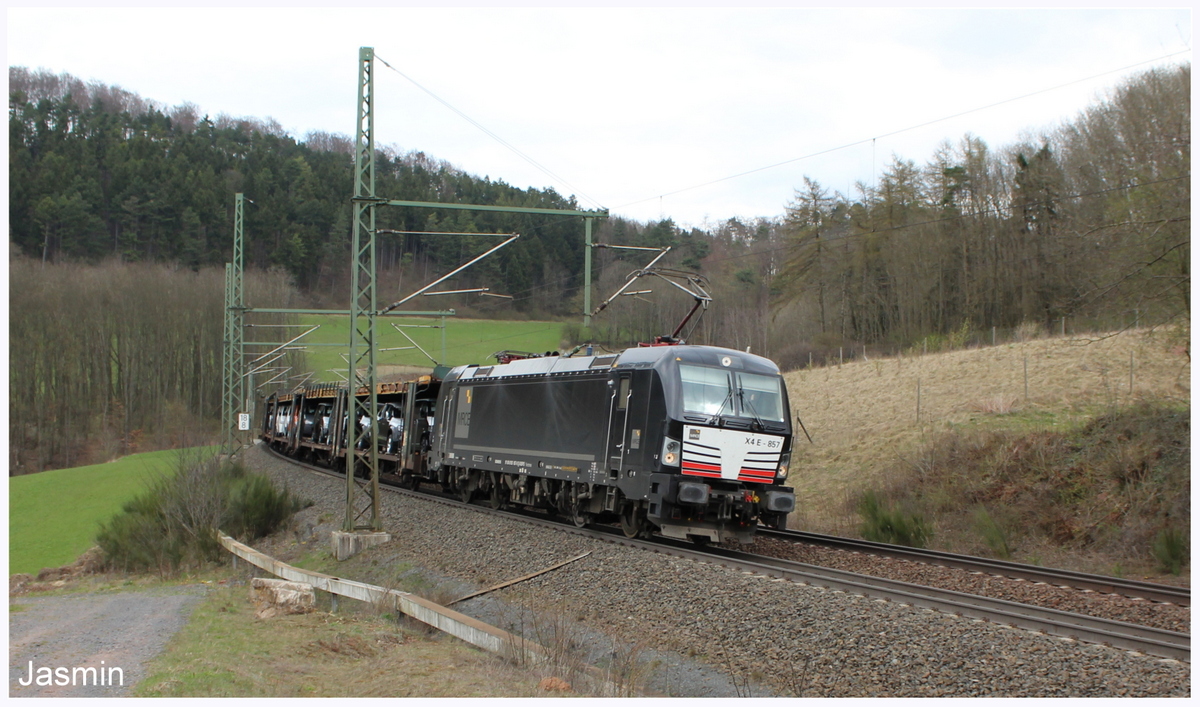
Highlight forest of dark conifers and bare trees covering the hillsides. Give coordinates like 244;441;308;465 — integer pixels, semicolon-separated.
8;65;1190;468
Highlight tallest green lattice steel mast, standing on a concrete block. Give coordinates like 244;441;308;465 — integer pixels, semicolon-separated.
342;47;383;533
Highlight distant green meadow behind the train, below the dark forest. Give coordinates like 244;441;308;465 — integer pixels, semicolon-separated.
292;314;563;382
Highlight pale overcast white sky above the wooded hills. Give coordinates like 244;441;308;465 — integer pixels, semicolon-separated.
6;7;1192;227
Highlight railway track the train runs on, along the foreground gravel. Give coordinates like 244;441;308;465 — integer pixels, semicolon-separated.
262;450;1190;663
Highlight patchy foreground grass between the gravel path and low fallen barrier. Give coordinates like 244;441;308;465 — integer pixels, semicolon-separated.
134;578;538;697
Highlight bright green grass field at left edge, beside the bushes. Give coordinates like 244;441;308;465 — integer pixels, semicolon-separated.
8;450;216;575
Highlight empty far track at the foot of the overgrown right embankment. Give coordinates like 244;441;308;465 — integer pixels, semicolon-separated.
758;528;1192;606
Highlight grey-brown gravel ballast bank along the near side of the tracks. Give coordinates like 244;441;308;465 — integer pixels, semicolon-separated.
247;450;1190;697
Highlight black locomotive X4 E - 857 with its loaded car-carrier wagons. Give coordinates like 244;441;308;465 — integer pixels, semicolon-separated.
263;346;796;543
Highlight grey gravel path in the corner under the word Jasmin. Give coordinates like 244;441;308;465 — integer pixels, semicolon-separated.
8;587;205;697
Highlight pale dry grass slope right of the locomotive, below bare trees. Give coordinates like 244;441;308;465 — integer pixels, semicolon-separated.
785;330;1192;534
